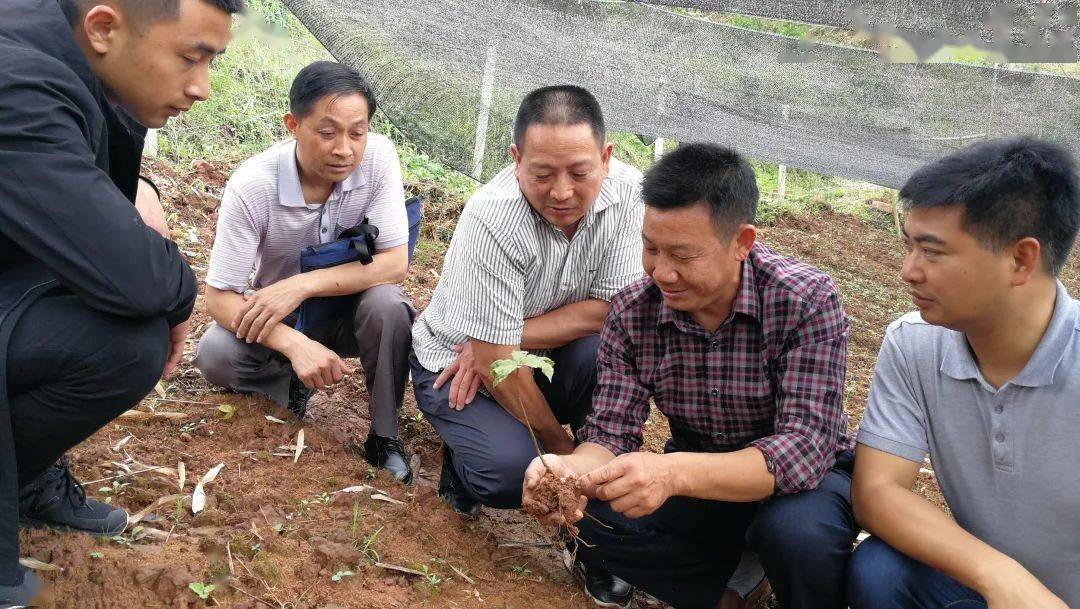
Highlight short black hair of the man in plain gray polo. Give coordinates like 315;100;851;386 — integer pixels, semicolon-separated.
900;137;1080;275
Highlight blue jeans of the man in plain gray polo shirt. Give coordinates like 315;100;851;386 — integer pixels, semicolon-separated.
848;537;986;609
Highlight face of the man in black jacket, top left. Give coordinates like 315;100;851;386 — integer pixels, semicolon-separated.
84;0;231;128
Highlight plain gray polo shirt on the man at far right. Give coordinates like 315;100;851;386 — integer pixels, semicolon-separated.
859;283;1080;607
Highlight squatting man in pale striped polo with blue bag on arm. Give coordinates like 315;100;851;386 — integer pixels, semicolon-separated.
195;62;414;482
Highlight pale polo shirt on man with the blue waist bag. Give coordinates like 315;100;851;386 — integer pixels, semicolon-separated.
206;132;408;293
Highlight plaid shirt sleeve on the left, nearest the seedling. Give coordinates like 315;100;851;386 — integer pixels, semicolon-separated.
578;312;651;455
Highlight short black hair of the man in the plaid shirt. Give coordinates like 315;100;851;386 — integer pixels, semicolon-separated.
642;143;759;238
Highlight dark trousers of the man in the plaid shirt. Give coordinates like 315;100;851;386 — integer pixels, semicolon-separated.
578;451;858;609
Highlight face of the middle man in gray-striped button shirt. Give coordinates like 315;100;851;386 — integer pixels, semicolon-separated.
510;123;612;232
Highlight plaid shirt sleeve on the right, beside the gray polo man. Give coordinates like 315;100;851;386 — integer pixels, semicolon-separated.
751;279;849;495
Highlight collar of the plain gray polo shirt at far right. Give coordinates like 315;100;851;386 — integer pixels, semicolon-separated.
941;281;1080;387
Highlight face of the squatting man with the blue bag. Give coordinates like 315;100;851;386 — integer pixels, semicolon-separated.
285;93;370;185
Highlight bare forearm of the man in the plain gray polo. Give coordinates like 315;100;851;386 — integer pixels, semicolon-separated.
851;444;1067;609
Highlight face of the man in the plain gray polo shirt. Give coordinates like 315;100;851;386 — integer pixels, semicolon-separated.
900;206;1015;331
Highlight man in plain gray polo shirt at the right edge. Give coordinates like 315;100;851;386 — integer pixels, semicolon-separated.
849;138;1080;609
